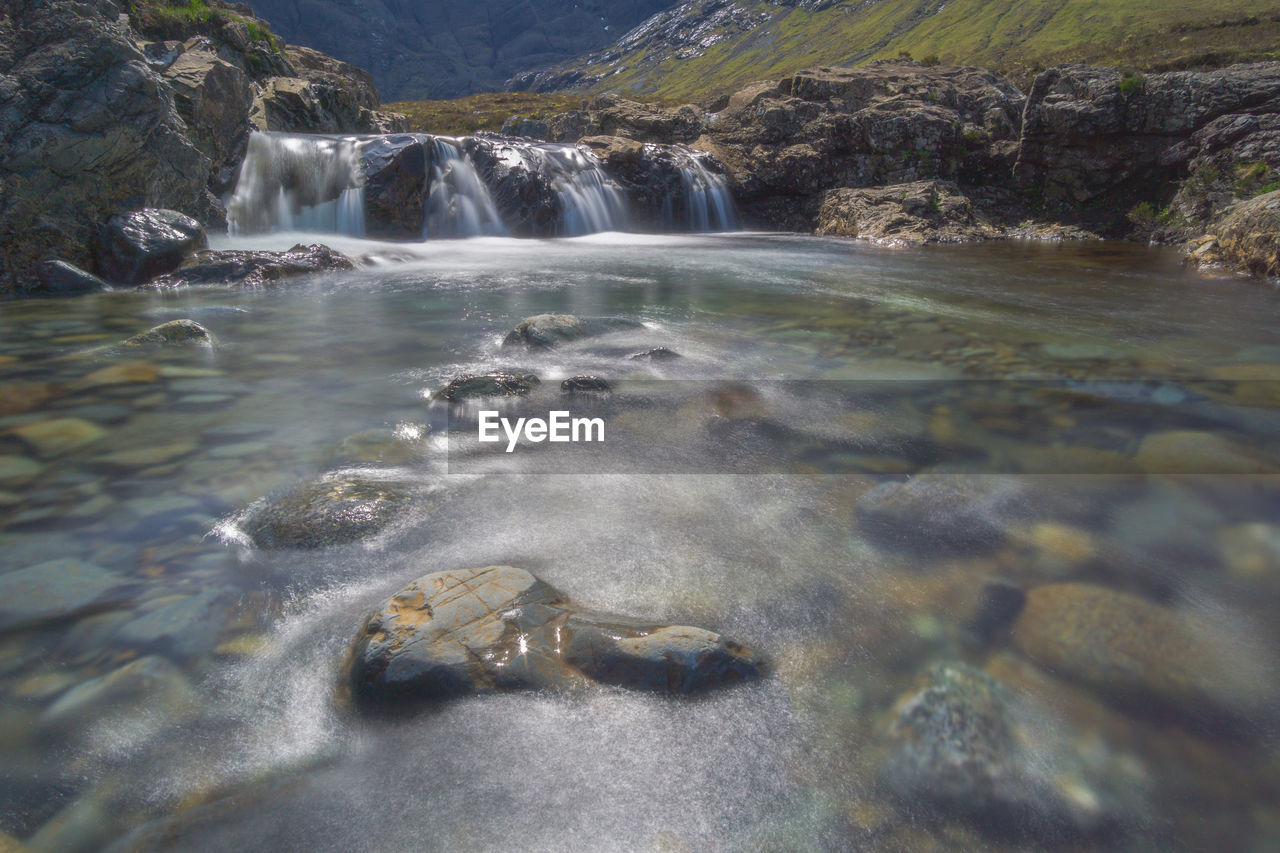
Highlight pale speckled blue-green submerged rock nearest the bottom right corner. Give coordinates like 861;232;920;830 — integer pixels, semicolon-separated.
878;662;1146;839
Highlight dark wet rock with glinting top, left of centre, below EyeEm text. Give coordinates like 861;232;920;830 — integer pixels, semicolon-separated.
239;478;412;548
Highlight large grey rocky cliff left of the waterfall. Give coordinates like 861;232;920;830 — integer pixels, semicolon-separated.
0;0;397;292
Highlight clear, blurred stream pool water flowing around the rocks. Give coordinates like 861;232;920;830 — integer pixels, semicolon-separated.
0;234;1280;850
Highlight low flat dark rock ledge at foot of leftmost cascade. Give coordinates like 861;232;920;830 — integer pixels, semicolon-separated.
148;243;356;288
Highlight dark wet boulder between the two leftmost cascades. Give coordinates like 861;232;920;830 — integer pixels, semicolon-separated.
360;133;433;240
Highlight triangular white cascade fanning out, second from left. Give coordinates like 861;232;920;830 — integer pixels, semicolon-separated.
422;136;507;240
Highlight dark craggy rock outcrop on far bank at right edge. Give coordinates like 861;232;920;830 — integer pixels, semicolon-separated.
1015;63;1280;234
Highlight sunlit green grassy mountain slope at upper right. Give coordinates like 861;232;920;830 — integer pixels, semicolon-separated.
509;0;1280;99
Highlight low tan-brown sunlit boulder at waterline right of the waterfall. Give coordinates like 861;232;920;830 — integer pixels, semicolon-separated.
814;181;1000;246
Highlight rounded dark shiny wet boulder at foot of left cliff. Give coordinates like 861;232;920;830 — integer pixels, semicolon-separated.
93;207;209;284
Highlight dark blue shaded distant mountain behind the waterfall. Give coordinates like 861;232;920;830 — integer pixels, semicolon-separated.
241;0;672;100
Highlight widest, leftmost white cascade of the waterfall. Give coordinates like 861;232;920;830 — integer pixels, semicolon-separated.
227;132;365;237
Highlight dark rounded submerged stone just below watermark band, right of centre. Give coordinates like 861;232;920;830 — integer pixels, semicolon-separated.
854;475;1019;556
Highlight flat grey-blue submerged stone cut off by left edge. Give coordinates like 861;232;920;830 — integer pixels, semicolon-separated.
0;558;125;631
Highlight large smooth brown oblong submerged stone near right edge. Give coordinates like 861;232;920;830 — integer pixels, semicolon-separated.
1012;584;1275;722
